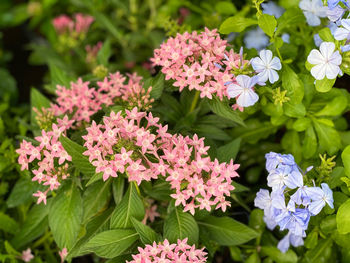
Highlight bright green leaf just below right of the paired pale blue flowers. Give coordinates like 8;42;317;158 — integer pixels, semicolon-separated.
282;64;304;104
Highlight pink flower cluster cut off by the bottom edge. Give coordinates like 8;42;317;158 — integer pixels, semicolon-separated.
127;238;207;263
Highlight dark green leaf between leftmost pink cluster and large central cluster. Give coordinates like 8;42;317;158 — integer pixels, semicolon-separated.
60;135;96;176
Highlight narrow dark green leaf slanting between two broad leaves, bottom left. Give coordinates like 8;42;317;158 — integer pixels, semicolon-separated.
67;208;113;261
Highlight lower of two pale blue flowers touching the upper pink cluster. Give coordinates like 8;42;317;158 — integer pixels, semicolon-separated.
227;75;259;107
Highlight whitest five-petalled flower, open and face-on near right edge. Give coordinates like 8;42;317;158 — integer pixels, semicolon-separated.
307;42;342;80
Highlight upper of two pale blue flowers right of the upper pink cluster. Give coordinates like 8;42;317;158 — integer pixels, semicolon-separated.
251;50;282;83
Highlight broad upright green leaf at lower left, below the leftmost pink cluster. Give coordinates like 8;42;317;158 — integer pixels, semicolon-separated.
49;184;83;250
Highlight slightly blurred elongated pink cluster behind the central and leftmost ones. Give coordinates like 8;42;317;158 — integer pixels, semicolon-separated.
50;72;154;128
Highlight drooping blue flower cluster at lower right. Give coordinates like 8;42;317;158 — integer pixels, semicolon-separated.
254;152;333;252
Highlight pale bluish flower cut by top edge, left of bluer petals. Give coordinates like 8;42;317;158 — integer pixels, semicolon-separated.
299;0;328;26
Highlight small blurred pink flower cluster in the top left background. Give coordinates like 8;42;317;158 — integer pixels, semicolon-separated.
52;13;94;35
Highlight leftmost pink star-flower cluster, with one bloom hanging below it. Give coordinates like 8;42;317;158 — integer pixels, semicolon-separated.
16;124;72;204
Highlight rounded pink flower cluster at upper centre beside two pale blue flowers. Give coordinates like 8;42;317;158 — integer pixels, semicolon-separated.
151;28;245;99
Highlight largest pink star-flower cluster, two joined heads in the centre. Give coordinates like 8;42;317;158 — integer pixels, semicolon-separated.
83;108;239;214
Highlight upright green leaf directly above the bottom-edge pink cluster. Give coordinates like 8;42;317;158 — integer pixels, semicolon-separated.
164;207;199;244
